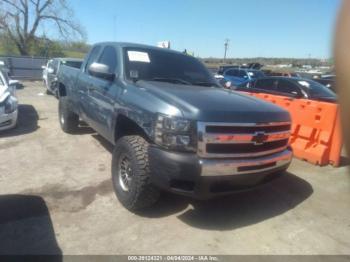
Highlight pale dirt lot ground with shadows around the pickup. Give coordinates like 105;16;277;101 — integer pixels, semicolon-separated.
0;82;350;254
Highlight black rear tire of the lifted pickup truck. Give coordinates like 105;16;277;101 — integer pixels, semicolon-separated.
58;96;79;134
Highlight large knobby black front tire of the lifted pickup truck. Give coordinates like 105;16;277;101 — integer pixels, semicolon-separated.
112;136;160;211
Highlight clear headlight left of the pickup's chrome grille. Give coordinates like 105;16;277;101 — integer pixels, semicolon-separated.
155;115;196;151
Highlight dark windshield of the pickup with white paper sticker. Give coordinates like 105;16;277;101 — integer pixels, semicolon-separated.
124;48;217;86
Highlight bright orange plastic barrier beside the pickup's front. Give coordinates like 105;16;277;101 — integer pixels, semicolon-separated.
242;92;343;167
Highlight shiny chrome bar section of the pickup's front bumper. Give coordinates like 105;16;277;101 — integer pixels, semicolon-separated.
199;149;293;177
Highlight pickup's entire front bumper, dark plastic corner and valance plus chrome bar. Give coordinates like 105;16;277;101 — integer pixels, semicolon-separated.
149;147;292;199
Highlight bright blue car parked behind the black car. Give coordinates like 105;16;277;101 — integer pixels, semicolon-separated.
224;69;265;85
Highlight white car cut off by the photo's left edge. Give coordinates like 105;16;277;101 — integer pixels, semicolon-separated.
0;70;18;131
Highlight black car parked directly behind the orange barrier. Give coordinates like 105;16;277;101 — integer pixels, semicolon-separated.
234;77;337;102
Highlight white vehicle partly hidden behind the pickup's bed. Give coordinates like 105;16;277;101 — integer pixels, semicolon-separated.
43;58;83;95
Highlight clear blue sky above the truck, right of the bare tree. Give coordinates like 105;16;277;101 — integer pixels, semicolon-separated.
69;0;340;58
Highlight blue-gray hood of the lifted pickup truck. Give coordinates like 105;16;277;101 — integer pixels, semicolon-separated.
137;81;290;123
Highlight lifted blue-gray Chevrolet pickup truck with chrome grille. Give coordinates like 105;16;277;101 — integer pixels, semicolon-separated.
58;43;292;210
